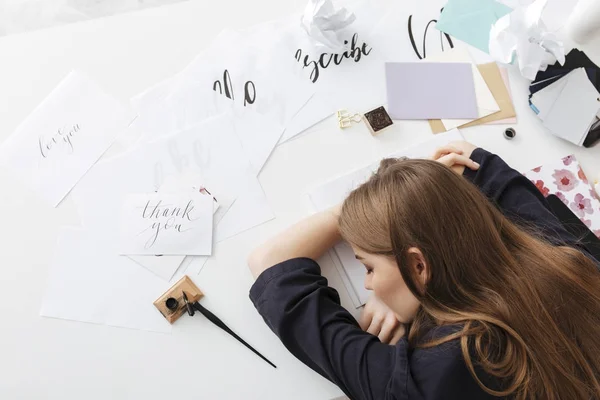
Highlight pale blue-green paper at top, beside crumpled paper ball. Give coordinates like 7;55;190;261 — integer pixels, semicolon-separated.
435;0;512;53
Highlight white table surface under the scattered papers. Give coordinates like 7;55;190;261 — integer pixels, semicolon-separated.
0;0;600;400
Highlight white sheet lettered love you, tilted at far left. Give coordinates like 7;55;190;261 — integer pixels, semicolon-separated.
0;71;133;207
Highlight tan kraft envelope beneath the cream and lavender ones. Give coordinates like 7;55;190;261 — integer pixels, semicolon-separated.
429;63;517;133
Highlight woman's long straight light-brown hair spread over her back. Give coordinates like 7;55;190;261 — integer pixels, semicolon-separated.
339;159;600;400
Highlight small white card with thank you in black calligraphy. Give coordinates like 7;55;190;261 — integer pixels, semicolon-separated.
119;191;214;256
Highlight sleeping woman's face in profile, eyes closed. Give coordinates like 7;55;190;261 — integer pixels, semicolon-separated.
352;246;420;323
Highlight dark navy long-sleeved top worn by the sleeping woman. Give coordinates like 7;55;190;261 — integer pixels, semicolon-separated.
250;149;576;400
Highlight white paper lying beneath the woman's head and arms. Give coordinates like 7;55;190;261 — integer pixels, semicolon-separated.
308;129;463;307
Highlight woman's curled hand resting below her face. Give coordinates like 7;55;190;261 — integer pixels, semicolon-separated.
359;296;405;345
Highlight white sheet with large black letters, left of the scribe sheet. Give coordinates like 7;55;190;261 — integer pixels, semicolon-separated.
132;29;302;173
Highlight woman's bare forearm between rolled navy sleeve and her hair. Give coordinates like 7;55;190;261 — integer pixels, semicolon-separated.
248;206;340;278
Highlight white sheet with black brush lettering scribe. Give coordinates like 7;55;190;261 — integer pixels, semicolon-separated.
274;2;391;143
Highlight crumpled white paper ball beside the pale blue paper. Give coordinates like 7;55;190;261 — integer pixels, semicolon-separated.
490;0;565;80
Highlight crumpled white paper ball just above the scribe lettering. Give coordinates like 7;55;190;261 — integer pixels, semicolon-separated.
301;0;356;51
